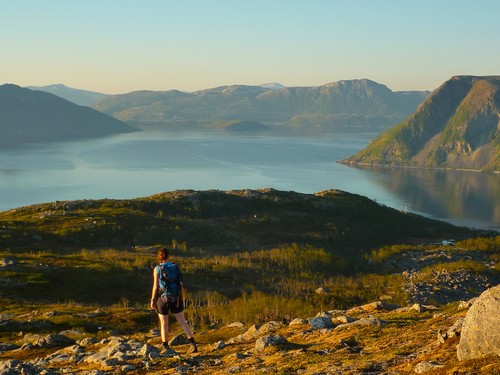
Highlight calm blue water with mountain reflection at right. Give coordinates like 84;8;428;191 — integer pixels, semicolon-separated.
0;132;500;230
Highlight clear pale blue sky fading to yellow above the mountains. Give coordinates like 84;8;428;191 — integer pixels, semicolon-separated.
0;0;500;93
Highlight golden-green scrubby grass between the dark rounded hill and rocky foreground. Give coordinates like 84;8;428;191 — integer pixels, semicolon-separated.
0;237;499;331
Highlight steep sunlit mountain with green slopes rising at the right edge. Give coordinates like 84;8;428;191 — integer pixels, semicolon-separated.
342;76;500;172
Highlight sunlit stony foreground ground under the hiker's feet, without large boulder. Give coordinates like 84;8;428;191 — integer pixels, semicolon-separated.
0;301;500;375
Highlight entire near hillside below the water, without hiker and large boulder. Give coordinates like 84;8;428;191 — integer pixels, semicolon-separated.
0;189;500;375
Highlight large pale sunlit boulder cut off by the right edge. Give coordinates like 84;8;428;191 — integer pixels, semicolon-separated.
457;285;500;361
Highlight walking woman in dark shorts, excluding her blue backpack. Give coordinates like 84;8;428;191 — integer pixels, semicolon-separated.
150;248;198;354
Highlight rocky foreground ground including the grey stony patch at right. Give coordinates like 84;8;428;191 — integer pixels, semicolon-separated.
0;242;500;375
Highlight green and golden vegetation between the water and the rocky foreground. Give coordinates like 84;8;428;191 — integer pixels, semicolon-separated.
0;190;500;331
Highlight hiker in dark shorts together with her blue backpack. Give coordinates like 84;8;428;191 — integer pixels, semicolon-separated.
150;248;198;354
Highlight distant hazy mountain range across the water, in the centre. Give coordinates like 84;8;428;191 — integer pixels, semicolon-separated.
94;79;428;128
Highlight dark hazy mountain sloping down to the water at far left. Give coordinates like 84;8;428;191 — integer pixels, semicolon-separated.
0;84;135;145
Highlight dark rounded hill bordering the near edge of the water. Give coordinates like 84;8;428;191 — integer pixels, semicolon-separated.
0;189;472;257
